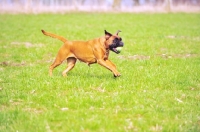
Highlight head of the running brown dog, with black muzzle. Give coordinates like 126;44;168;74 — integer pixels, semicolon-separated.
105;30;124;54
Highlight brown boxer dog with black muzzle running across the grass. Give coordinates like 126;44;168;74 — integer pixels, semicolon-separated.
42;30;124;77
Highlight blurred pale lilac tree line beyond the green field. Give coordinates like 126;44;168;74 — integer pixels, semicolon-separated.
0;0;200;11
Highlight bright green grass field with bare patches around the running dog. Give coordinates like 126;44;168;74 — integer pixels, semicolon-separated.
0;13;200;132
